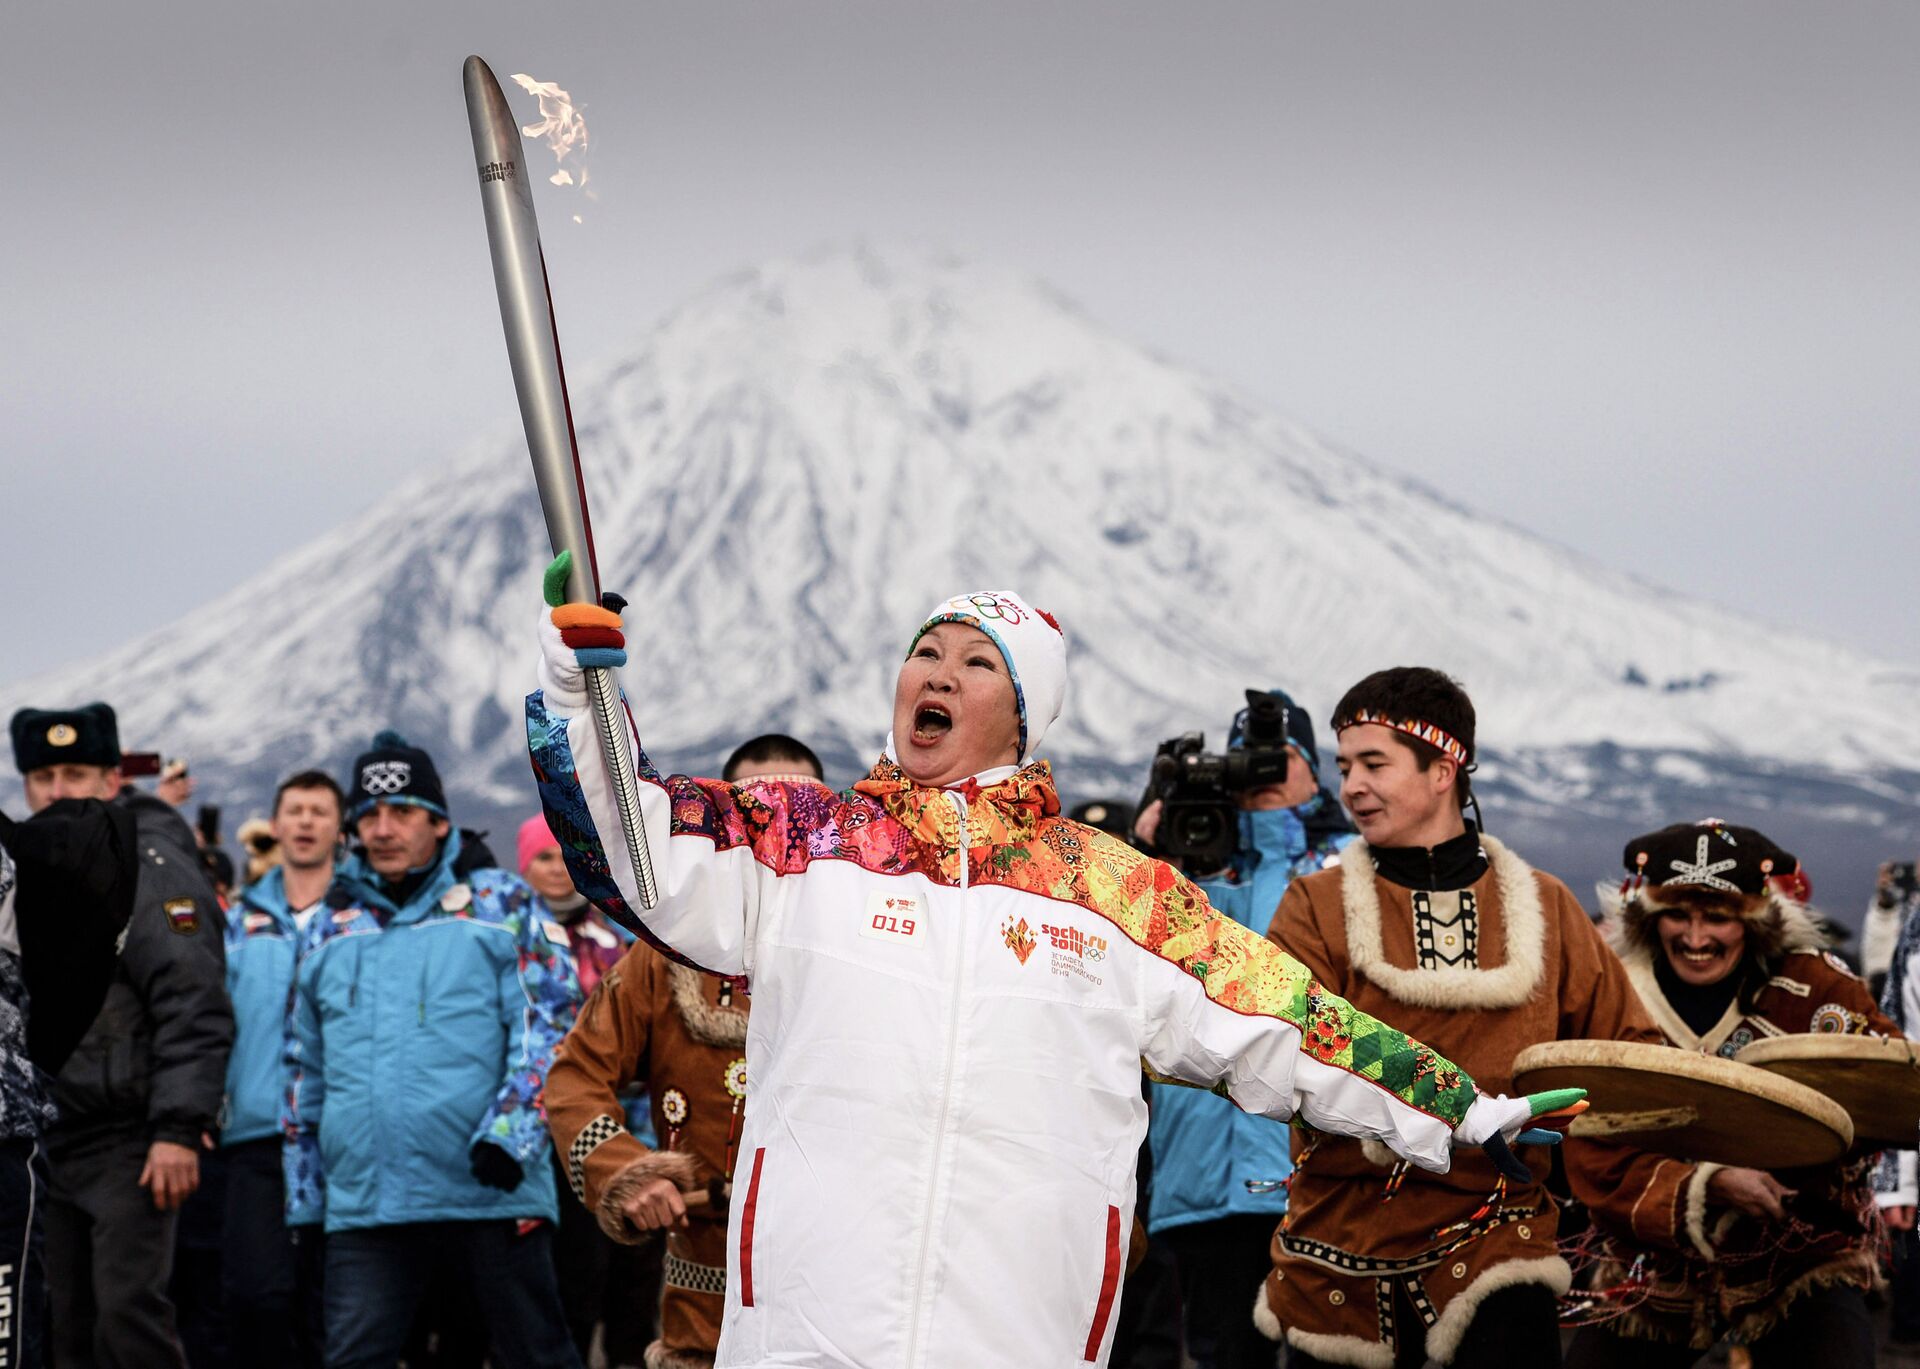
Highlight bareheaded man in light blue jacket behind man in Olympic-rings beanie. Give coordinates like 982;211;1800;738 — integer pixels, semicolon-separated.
221;770;346;1369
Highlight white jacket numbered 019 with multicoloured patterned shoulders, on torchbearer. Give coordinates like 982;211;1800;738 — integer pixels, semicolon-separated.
528;693;1475;1369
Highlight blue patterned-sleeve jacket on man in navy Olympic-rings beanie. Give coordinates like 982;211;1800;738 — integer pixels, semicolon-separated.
282;831;580;1231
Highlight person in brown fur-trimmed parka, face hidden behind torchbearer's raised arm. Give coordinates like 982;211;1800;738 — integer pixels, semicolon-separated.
547;943;749;1369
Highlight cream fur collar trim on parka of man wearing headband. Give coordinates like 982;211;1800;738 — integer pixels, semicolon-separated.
1340;835;1546;1010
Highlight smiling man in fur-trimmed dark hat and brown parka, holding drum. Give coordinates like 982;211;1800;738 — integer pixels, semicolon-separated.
1567;820;1901;1369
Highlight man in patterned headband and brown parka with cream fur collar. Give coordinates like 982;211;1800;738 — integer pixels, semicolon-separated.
1254;666;1659;1369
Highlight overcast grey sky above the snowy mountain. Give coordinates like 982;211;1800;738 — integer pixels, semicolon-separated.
0;0;1920;680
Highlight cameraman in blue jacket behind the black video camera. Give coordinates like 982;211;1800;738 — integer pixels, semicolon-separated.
1135;689;1356;1369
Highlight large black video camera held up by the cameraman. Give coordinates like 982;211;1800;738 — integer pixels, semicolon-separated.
1146;689;1288;874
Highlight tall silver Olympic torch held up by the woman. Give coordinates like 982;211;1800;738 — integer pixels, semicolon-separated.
463;58;659;908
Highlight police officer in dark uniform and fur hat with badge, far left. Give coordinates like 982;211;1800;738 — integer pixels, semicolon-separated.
10;703;234;1369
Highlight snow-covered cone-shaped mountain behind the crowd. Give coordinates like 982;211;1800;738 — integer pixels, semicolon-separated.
4;248;1920;917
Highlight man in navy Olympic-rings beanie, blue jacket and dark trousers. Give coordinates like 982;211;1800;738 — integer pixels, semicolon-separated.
284;732;580;1369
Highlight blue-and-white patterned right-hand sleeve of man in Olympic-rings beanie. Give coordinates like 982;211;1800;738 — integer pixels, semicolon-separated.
472;872;580;1167
